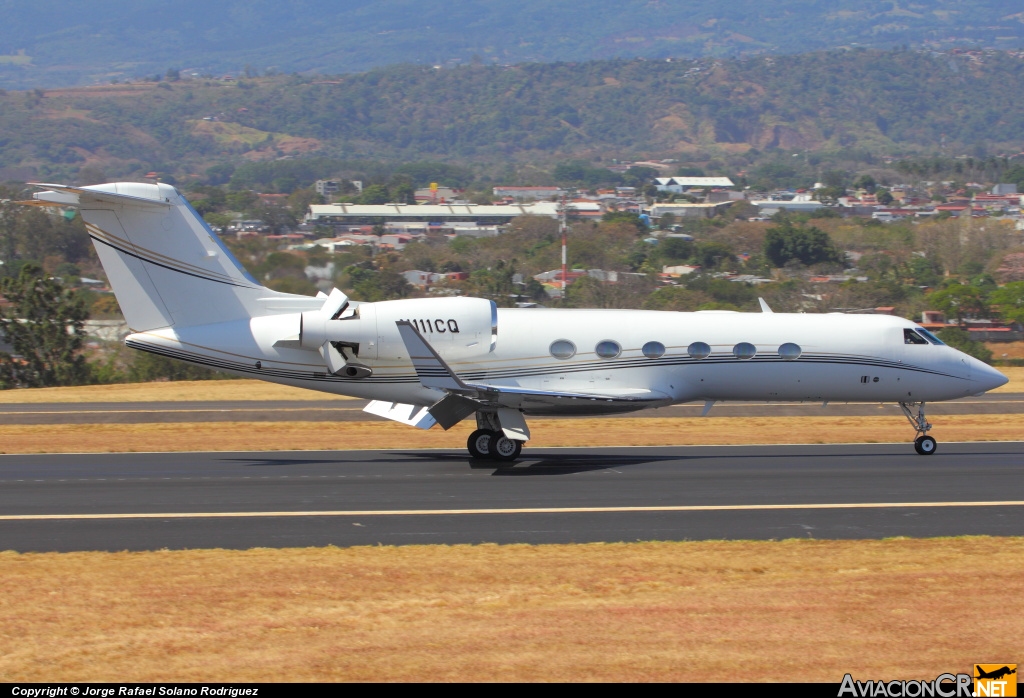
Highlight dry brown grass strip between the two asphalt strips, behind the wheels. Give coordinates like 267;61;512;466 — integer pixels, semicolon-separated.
0;415;1024;454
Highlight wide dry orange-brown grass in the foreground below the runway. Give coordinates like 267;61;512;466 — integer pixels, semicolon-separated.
0;537;1024;682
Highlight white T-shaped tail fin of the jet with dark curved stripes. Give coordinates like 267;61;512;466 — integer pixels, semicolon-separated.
35;182;270;332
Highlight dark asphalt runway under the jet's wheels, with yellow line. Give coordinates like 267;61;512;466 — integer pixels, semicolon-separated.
0;442;1024;552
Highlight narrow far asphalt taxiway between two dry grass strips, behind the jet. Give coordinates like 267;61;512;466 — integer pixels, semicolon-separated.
6;393;1024;425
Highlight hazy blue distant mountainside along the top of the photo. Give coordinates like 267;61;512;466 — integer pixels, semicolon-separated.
0;0;1024;89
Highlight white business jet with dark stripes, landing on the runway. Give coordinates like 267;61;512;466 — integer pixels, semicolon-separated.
27;182;1007;461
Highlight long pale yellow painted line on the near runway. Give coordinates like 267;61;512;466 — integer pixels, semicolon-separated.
6;500;1024;521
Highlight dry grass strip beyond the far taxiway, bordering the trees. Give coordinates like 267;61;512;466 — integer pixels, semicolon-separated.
0;364;1024;404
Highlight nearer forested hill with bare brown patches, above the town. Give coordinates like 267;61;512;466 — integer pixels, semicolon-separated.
6;50;1024;180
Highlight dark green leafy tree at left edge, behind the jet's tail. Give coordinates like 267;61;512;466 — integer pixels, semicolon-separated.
0;263;90;388
